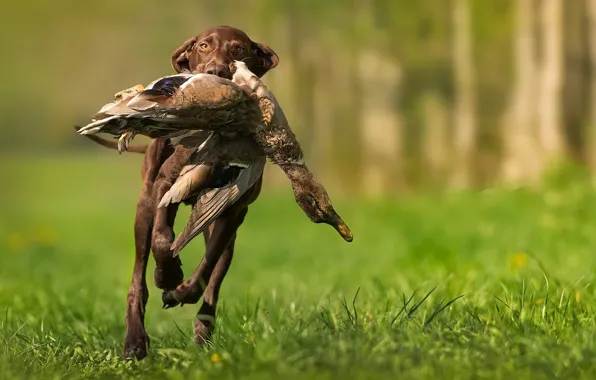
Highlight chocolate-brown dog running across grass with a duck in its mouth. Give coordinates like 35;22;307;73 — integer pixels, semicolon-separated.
81;26;279;359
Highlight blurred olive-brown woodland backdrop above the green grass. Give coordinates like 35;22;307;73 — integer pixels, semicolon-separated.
0;0;596;191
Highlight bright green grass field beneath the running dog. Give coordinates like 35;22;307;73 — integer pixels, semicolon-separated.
0;155;596;380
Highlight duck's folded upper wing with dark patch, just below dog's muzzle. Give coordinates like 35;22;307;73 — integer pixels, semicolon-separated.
79;74;256;138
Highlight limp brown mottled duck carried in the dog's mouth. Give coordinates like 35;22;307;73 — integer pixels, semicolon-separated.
78;61;353;249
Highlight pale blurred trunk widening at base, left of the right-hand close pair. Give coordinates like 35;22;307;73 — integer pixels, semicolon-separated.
502;0;542;182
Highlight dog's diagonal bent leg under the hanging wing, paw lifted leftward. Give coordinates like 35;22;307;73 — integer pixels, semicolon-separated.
162;206;248;309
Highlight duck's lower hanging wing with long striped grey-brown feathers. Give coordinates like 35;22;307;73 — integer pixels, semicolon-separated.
171;156;265;257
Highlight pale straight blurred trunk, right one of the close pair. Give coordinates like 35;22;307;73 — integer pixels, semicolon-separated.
538;0;565;164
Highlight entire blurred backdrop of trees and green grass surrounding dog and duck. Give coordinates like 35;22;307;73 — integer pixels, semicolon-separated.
0;0;596;379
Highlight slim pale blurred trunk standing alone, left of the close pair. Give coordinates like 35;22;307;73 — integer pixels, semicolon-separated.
451;0;476;187
